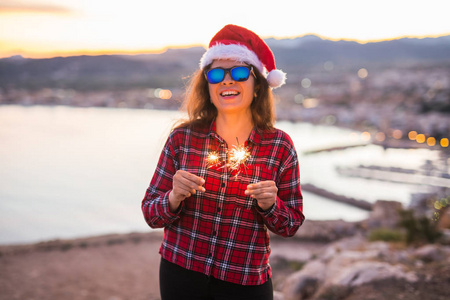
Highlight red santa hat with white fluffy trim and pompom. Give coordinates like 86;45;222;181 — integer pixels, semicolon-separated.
200;25;286;88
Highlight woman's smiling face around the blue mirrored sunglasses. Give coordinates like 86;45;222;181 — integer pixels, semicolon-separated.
208;60;255;115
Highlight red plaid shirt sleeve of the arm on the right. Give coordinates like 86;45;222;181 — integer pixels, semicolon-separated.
257;141;305;237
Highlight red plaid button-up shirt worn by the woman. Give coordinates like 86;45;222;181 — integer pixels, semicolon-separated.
142;123;305;285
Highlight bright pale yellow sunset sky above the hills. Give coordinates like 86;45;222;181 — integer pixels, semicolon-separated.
0;0;450;57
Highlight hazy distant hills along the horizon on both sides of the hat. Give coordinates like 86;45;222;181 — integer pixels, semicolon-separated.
0;35;450;90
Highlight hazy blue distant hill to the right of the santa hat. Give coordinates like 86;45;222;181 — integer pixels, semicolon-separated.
266;36;450;68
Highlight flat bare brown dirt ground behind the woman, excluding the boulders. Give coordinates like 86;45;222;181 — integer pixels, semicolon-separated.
0;232;323;300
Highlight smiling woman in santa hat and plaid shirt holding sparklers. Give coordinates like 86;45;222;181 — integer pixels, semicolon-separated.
142;25;304;300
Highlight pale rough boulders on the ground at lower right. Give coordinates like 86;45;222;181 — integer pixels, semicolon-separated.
276;235;450;300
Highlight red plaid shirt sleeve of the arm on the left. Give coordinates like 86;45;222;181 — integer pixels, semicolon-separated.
141;134;183;228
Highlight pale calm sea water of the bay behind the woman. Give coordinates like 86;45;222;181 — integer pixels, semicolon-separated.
0;105;438;244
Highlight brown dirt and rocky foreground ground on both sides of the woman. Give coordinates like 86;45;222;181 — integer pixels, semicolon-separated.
0;213;450;300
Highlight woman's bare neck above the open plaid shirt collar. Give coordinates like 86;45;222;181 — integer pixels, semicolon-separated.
216;112;253;147
